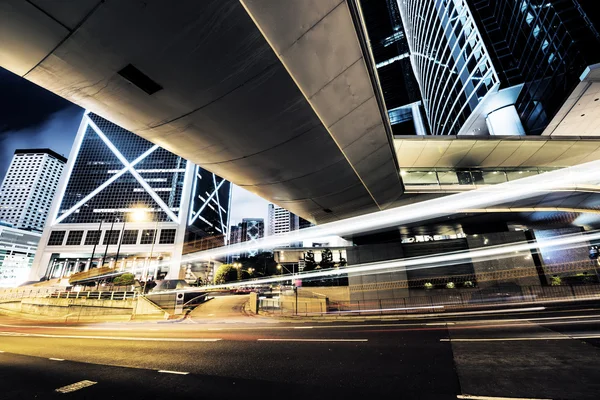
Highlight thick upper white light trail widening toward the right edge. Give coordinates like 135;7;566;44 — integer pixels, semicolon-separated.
179;161;600;265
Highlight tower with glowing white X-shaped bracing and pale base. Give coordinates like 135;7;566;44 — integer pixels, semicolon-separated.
31;113;230;280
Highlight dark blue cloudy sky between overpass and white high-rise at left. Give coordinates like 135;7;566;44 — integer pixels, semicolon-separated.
0;68;83;181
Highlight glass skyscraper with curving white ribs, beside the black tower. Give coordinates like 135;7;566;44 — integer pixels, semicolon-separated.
398;0;499;135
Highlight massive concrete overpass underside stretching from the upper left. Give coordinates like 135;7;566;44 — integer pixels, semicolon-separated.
0;0;403;223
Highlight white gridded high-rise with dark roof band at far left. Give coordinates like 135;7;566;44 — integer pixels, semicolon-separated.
0;149;67;232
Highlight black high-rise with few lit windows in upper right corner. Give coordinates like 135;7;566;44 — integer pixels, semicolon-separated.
470;0;600;135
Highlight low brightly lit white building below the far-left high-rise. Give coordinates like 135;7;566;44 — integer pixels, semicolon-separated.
0;224;42;288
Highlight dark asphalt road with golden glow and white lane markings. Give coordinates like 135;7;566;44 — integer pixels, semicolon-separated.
0;296;600;399
